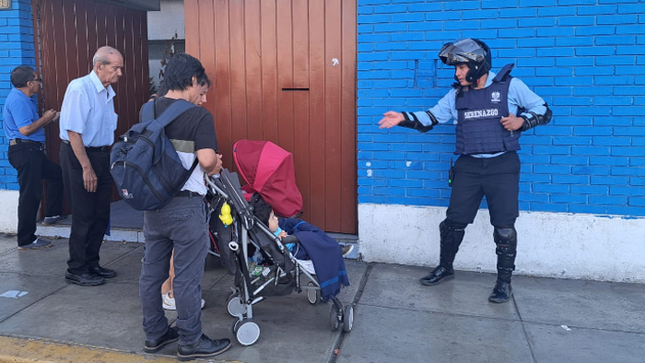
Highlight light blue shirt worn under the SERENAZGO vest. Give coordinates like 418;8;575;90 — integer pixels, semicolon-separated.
414;72;546;157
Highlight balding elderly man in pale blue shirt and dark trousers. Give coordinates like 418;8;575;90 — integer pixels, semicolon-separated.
60;46;123;286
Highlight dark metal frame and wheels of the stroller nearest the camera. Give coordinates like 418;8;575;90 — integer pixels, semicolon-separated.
207;169;354;346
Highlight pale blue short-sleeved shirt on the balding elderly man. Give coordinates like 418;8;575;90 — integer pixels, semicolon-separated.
60;71;119;147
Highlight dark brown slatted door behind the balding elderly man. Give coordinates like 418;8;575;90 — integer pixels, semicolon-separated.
33;0;149;206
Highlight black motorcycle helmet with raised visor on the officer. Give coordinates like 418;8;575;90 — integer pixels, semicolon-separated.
439;38;493;83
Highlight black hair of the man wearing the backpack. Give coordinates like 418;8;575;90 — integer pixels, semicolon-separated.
163;53;211;91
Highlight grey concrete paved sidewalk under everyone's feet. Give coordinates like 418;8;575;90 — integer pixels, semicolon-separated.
0;235;645;363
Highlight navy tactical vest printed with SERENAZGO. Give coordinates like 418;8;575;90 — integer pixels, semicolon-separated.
455;64;520;155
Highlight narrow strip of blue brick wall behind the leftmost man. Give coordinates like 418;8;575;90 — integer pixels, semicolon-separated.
0;0;36;190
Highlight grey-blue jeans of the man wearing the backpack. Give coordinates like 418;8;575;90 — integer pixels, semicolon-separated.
139;195;209;345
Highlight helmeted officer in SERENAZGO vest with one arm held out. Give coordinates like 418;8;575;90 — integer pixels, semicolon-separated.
379;38;551;303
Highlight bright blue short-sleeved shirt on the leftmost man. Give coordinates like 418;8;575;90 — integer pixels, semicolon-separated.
2;88;45;143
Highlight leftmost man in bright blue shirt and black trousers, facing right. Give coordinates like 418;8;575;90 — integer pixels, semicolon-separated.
2;66;63;250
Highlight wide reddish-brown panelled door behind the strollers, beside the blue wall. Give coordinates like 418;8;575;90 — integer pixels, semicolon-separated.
184;0;357;234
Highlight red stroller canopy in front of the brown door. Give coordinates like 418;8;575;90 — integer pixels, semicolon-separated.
233;140;302;217
